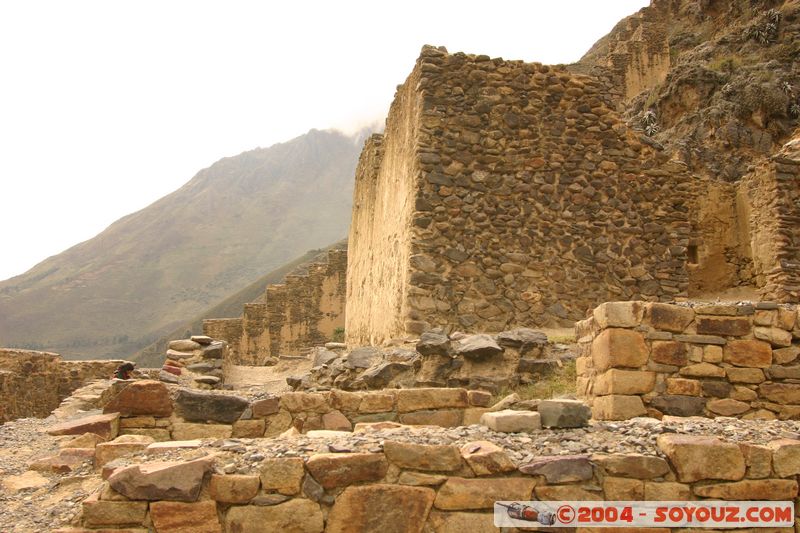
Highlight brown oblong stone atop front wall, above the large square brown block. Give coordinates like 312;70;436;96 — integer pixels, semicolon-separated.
304;453;389;489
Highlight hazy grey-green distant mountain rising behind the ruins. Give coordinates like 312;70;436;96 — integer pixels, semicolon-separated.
0;130;365;359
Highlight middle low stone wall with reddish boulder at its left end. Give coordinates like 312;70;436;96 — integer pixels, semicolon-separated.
92;380;491;441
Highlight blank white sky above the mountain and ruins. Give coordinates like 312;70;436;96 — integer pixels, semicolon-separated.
0;0;648;280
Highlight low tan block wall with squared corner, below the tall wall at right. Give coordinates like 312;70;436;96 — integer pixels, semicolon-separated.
576;302;800;420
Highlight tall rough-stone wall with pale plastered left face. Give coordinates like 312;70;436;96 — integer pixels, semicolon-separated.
346;47;690;344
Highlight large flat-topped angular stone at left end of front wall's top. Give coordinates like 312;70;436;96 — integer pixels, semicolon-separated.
108;456;214;502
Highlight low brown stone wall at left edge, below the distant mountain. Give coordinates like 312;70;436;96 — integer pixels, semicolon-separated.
0;348;123;423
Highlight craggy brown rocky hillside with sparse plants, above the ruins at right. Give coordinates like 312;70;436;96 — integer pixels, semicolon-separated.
575;0;800;181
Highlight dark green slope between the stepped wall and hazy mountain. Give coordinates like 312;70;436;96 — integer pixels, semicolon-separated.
130;240;347;367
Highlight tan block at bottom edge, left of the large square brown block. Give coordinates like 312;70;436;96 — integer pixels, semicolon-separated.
224;498;325;533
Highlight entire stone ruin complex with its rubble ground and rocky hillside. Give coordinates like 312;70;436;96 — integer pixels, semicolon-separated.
0;0;800;533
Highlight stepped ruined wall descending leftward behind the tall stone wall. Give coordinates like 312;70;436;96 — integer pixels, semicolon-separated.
203;250;347;365
